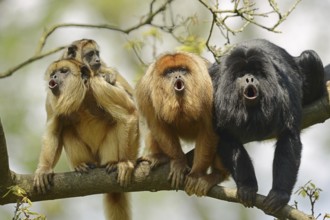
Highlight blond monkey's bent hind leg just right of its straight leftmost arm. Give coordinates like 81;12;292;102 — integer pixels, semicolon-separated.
63;129;97;172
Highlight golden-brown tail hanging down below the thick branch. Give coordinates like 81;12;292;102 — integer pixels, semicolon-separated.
103;193;131;220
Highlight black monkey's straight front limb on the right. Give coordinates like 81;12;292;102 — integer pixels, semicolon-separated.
264;130;302;213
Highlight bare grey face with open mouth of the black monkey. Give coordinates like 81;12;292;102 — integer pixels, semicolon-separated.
237;73;260;106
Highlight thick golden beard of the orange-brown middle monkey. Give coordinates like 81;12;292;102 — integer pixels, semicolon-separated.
150;73;213;124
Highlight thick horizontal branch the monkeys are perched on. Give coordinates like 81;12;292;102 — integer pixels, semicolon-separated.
0;164;311;220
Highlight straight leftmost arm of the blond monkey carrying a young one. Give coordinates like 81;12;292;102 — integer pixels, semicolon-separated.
33;116;62;193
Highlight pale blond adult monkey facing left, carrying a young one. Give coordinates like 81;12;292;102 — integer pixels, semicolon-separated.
34;59;139;219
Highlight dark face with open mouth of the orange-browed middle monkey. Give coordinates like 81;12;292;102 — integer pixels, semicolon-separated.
164;66;189;95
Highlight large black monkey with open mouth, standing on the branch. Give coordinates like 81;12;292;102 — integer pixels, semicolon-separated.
209;40;324;213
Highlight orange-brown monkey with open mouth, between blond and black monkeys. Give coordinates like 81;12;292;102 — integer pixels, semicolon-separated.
136;52;228;196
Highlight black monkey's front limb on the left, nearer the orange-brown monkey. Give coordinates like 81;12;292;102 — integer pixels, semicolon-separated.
217;134;258;207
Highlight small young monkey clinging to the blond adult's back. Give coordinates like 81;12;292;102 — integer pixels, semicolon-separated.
62;39;133;96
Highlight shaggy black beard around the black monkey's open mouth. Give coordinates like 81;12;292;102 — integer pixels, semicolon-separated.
215;73;290;138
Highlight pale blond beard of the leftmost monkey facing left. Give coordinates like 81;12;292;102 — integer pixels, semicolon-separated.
49;75;88;115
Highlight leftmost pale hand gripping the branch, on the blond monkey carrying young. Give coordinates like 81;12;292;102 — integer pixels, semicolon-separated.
33;167;54;194
